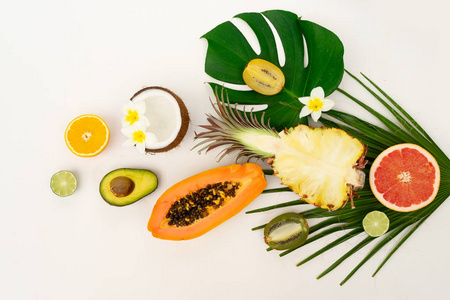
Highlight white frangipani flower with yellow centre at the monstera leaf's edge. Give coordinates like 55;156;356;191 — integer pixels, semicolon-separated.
298;86;334;122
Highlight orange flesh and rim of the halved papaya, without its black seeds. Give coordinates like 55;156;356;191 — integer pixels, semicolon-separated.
147;163;267;240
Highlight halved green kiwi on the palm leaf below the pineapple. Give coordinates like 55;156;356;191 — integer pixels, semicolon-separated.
264;213;309;250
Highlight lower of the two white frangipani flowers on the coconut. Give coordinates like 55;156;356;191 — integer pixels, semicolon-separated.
122;120;158;154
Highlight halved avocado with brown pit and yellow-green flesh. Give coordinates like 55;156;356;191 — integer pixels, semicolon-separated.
100;168;158;206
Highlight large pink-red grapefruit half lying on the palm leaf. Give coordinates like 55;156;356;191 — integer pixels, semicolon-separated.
369;144;440;212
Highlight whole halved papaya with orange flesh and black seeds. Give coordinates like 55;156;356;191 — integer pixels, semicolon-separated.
147;163;267;240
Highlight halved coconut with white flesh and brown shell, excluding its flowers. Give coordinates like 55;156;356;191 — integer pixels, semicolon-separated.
130;86;189;153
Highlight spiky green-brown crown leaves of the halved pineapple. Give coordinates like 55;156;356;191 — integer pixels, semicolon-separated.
193;87;278;161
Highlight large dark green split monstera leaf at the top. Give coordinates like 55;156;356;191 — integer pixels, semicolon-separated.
203;10;344;130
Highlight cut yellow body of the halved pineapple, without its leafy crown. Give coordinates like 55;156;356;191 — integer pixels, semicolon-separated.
272;125;364;210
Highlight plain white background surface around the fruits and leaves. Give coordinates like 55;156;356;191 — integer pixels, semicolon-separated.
0;0;450;300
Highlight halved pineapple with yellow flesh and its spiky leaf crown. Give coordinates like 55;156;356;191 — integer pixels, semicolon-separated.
195;92;365;210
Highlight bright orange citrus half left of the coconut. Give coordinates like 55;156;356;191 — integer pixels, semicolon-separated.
65;115;109;157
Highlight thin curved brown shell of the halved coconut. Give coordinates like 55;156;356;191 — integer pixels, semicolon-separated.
130;86;190;154
